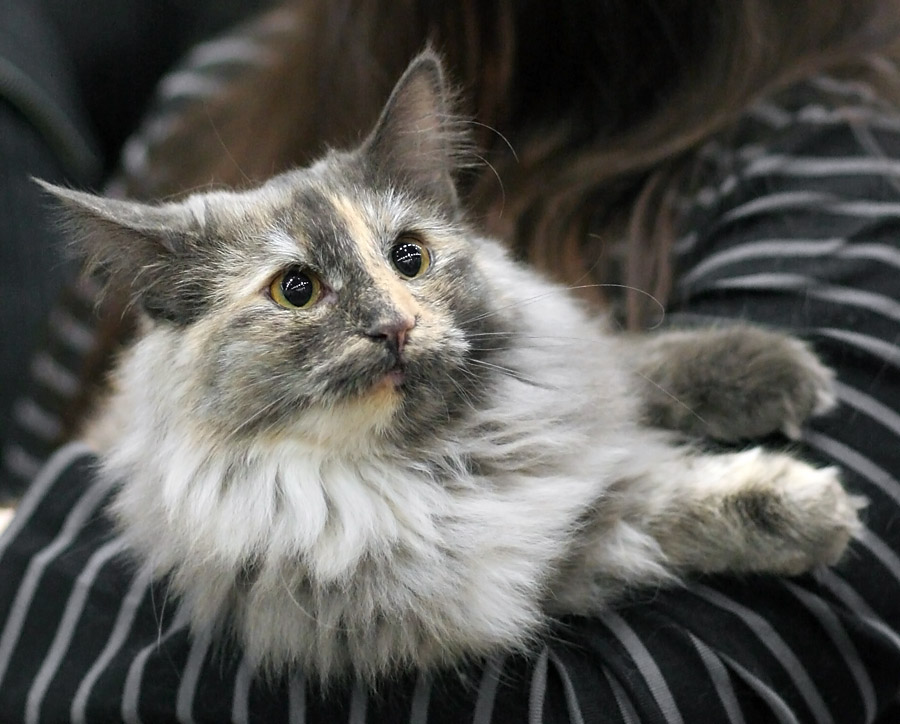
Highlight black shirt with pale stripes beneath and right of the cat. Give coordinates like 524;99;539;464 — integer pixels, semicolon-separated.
0;70;900;724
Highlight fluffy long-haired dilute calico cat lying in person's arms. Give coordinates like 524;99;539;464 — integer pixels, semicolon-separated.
45;50;862;680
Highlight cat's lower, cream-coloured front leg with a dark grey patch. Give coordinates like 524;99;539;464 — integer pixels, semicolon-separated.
551;448;864;611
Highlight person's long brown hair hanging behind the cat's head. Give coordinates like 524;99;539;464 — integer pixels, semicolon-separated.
126;0;900;326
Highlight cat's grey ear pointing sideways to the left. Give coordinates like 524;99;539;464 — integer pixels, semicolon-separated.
35;179;203;322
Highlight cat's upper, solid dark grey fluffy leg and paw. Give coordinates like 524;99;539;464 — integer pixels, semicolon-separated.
625;325;834;441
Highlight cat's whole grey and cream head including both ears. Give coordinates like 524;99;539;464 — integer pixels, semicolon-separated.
47;51;509;450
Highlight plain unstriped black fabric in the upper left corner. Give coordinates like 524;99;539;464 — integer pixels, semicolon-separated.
0;0;269;492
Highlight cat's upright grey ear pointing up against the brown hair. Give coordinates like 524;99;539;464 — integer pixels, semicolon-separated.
362;50;472;207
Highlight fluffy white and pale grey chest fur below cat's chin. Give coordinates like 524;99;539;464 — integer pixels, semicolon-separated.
107;408;612;675
